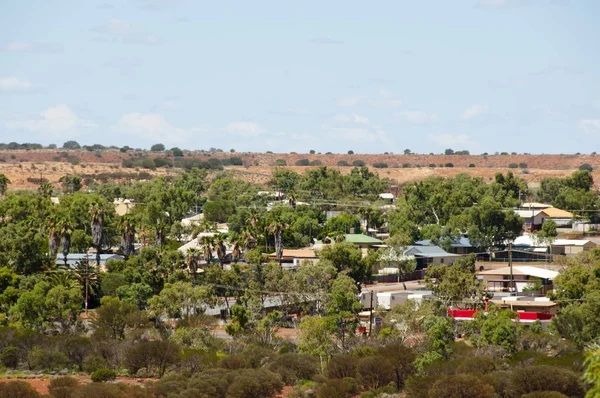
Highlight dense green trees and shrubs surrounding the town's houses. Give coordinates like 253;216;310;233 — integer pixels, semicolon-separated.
0;166;600;397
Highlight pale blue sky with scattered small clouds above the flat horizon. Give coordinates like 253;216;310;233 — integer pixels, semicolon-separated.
0;0;600;153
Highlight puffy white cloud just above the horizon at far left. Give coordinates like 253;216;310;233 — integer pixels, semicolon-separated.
6;104;97;137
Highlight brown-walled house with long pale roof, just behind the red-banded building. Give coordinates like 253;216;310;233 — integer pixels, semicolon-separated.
478;265;558;294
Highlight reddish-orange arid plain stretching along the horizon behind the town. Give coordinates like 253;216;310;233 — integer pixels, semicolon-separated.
0;150;600;189
